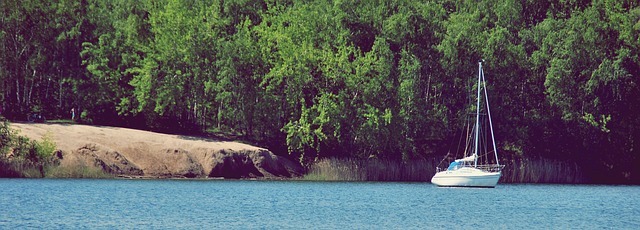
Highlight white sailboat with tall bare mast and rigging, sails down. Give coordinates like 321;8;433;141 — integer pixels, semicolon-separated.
431;61;504;188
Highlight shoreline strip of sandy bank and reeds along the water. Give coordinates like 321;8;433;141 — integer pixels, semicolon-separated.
3;123;639;185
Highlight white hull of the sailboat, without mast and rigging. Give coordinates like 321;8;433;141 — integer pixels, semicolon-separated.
431;167;501;188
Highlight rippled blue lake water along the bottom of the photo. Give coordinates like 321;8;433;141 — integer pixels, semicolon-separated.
0;179;640;229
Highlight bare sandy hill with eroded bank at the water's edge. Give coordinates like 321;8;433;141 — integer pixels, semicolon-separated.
11;123;302;178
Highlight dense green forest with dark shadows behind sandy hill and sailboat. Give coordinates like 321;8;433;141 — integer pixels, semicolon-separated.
0;0;640;183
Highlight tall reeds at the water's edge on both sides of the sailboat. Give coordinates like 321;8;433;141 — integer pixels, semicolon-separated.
304;158;588;184
